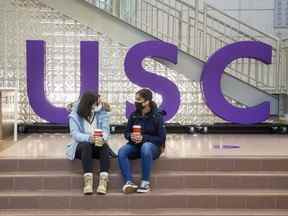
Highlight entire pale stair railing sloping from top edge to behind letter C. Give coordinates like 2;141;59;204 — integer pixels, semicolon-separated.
86;0;287;93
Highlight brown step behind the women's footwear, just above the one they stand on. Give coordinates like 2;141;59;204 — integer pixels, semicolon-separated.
0;171;288;191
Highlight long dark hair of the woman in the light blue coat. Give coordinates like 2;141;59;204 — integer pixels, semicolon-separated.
77;91;99;122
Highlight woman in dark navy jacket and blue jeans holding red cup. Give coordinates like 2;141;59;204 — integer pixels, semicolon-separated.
118;89;166;193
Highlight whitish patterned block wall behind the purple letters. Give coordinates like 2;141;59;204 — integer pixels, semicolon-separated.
0;0;243;124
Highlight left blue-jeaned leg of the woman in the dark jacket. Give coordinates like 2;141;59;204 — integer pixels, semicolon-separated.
118;143;139;182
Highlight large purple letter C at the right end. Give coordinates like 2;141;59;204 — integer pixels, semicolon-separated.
201;41;272;124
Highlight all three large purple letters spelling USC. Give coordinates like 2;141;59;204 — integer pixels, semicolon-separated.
26;40;272;124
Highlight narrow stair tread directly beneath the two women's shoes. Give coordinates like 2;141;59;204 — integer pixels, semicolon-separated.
0;188;288;197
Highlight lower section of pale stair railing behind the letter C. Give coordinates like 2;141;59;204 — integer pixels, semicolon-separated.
203;4;286;93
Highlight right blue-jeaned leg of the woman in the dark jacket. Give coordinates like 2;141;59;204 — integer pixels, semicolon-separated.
141;142;160;182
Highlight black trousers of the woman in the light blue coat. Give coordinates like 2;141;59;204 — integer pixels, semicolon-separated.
75;142;110;173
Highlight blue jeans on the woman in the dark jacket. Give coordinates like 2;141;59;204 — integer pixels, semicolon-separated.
118;142;161;182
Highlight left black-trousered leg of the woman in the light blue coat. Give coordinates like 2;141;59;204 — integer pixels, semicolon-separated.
76;142;93;173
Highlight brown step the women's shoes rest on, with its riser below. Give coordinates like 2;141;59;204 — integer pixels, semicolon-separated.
0;188;288;210
